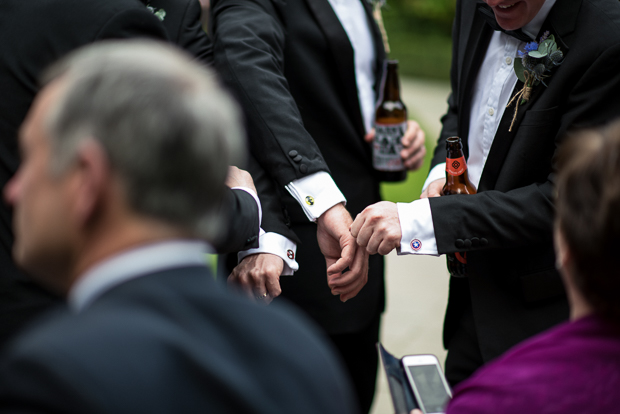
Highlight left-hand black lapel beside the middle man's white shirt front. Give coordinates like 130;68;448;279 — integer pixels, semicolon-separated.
306;0;366;137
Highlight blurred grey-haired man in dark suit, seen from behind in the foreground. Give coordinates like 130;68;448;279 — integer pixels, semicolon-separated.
0;41;356;414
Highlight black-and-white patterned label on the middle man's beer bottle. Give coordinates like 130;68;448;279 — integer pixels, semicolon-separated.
372;121;407;171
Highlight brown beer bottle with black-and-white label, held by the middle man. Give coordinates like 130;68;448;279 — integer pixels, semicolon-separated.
372;60;407;181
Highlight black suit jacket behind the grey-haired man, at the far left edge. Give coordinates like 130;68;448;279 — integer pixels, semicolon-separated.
0;0;167;350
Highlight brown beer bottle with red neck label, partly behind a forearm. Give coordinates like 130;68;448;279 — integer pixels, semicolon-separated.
441;137;476;277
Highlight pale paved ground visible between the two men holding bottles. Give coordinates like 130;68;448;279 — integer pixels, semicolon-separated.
371;79;450;414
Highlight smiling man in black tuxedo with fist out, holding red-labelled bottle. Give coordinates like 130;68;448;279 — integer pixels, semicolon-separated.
352;0;620;384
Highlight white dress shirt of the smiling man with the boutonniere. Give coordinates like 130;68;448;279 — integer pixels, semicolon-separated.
397;0;556;256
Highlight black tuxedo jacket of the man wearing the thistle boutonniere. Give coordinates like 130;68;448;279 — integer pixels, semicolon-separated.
430;0;620;360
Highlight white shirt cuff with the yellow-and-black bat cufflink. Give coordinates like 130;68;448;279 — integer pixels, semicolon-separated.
286;171;347;221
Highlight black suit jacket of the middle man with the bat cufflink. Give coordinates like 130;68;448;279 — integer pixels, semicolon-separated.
209;0;384;333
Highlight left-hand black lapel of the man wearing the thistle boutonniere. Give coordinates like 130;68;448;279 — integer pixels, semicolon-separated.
458;4;493;157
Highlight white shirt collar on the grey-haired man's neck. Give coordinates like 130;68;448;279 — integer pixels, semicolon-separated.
68;240;212;312
